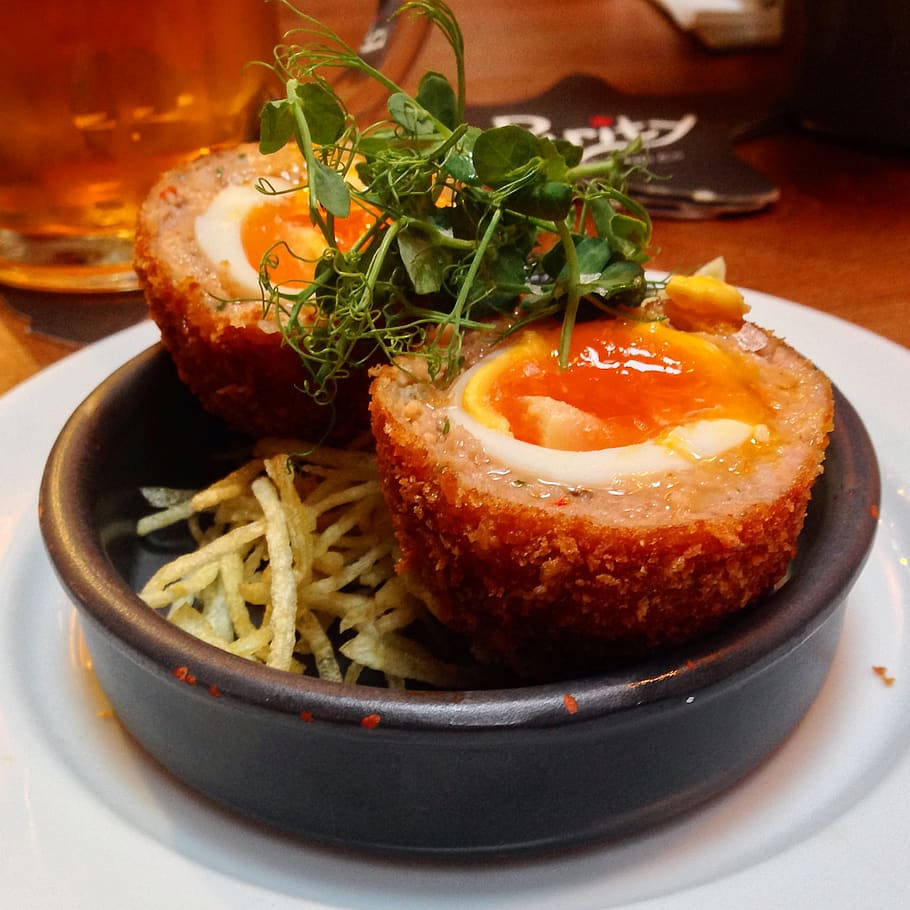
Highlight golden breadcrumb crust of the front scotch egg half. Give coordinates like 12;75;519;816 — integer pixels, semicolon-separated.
371;322;833;676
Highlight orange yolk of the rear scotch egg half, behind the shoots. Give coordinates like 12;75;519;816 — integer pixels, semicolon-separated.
240;190;373;285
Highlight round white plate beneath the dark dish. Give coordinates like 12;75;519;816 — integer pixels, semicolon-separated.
0;293;910;910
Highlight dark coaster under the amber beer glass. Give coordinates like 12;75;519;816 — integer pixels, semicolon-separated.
0;286;148;344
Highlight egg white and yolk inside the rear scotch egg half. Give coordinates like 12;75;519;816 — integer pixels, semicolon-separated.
195;177;373;297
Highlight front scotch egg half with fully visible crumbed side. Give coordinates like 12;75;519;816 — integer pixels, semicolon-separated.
371;285;833;677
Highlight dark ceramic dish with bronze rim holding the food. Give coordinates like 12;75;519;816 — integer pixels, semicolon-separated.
41;348;879;856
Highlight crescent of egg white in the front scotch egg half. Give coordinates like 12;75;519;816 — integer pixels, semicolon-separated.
447;354;767;487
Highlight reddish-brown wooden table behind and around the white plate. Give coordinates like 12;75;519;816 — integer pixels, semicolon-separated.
0;0;910;400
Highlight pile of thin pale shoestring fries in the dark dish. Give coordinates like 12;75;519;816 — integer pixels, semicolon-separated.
137;439;476;689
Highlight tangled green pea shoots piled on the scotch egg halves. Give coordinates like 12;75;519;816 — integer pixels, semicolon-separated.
260;0;654;401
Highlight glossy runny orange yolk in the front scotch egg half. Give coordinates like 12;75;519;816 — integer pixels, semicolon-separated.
463;319;767;451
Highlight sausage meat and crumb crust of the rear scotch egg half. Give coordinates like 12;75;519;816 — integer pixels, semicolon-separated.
134;145;368;441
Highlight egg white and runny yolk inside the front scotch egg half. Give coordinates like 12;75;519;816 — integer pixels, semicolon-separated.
448;319;768;486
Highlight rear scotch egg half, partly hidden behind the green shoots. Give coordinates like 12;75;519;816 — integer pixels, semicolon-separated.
134;144;372;440
